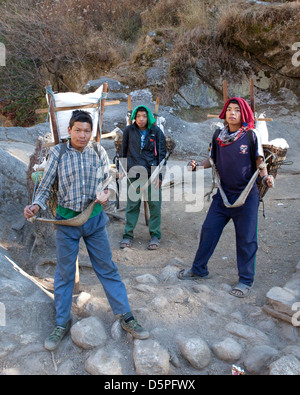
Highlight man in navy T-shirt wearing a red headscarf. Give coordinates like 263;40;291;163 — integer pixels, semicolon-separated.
178;97;274;298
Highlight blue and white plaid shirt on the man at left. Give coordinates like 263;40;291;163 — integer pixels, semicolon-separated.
33;142;116;212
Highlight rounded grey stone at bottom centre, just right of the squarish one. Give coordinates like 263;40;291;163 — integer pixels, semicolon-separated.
177;337;211;370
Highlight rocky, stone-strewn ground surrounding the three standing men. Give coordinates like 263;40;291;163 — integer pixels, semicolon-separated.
0;95;300;377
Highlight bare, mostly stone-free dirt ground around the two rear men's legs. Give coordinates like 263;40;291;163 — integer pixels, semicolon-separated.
108;159;300;305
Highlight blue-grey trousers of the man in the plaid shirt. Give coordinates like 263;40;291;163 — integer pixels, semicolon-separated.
54;212;130;326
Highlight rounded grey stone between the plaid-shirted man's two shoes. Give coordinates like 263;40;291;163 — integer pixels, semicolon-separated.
71;317;107;350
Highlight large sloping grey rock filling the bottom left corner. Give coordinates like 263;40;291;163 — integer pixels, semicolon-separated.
0;247;55;375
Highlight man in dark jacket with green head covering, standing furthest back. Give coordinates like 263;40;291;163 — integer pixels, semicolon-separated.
120;106;167;250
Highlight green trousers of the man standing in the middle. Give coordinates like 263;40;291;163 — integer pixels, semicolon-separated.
123;179;161;240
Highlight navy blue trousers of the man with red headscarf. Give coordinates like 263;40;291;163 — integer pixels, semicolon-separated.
192;191;259;285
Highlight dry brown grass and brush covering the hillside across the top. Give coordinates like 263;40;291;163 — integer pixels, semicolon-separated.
0;0;300;125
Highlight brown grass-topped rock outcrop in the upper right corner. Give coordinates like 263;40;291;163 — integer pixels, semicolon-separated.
218;4;300;77
